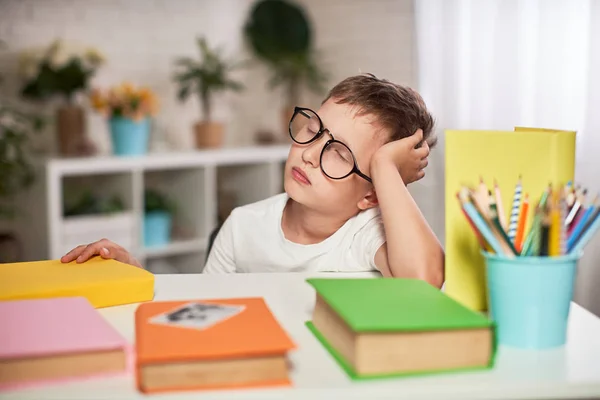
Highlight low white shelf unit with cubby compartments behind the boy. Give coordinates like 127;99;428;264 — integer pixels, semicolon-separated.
38;146;289;273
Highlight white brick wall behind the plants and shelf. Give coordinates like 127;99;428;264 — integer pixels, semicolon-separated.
0;0;416;151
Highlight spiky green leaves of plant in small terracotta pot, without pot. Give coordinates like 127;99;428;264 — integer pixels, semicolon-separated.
174;38;246;121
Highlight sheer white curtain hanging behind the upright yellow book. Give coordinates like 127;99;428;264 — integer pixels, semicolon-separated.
415;0;600;314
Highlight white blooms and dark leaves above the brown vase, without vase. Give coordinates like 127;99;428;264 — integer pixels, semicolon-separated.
20;40;104;103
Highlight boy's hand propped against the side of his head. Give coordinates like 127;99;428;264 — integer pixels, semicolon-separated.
371;129;429;185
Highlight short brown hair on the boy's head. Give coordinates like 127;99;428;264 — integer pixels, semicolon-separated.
323;74;437;147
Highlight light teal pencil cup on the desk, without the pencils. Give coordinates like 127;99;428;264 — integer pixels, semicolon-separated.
483;252;580;349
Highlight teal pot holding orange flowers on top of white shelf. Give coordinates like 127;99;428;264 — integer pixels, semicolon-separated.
109;117;150;156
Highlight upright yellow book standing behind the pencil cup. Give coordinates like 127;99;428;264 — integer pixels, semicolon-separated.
445;127;575;311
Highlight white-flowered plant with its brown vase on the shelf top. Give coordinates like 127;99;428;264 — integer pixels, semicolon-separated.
20;40;104;155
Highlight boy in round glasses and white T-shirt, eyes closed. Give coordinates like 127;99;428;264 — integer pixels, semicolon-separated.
63;74;444;288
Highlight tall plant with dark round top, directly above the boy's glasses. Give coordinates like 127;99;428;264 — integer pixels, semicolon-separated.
244;0;327;132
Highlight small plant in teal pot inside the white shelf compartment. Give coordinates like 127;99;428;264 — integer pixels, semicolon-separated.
143;189;175;247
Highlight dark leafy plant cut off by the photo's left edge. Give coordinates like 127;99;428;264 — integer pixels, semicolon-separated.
0;39;44;219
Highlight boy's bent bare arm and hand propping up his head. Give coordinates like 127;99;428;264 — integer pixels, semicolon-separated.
370;130;444;288
